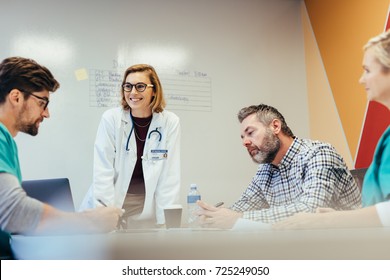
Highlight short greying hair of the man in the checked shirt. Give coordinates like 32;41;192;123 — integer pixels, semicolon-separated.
238;104;295;137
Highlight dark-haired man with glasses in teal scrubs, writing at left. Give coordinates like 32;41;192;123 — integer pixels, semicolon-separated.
0;57;122;259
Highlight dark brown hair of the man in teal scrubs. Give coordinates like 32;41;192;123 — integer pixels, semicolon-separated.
0;56;60;104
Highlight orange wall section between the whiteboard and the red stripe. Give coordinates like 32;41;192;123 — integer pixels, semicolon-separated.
305;0;389;160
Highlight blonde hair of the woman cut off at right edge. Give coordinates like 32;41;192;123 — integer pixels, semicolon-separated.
363;29;390;71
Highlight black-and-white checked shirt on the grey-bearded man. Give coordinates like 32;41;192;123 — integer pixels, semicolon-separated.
231;138;361;223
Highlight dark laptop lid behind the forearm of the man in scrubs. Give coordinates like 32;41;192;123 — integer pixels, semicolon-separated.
22;178;75;212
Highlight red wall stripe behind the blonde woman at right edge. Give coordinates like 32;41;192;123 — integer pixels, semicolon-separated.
355;10;390;168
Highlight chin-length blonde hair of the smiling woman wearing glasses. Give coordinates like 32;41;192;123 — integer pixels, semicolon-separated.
121;64;166;113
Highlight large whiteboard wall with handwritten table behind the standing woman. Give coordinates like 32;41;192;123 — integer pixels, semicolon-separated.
0;0;309;209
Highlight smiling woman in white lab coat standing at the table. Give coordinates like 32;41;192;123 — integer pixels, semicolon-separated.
81;64;180;228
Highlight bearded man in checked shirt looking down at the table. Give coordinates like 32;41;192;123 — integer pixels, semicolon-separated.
198;104;361;228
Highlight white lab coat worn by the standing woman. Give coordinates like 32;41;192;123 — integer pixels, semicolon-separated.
80;107;180;224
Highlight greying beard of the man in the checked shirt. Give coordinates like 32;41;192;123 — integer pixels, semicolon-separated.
249;129;280;164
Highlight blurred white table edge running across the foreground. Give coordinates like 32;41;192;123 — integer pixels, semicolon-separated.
11;228;390;260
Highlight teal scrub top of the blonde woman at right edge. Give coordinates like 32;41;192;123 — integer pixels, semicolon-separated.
362;126;390;207
